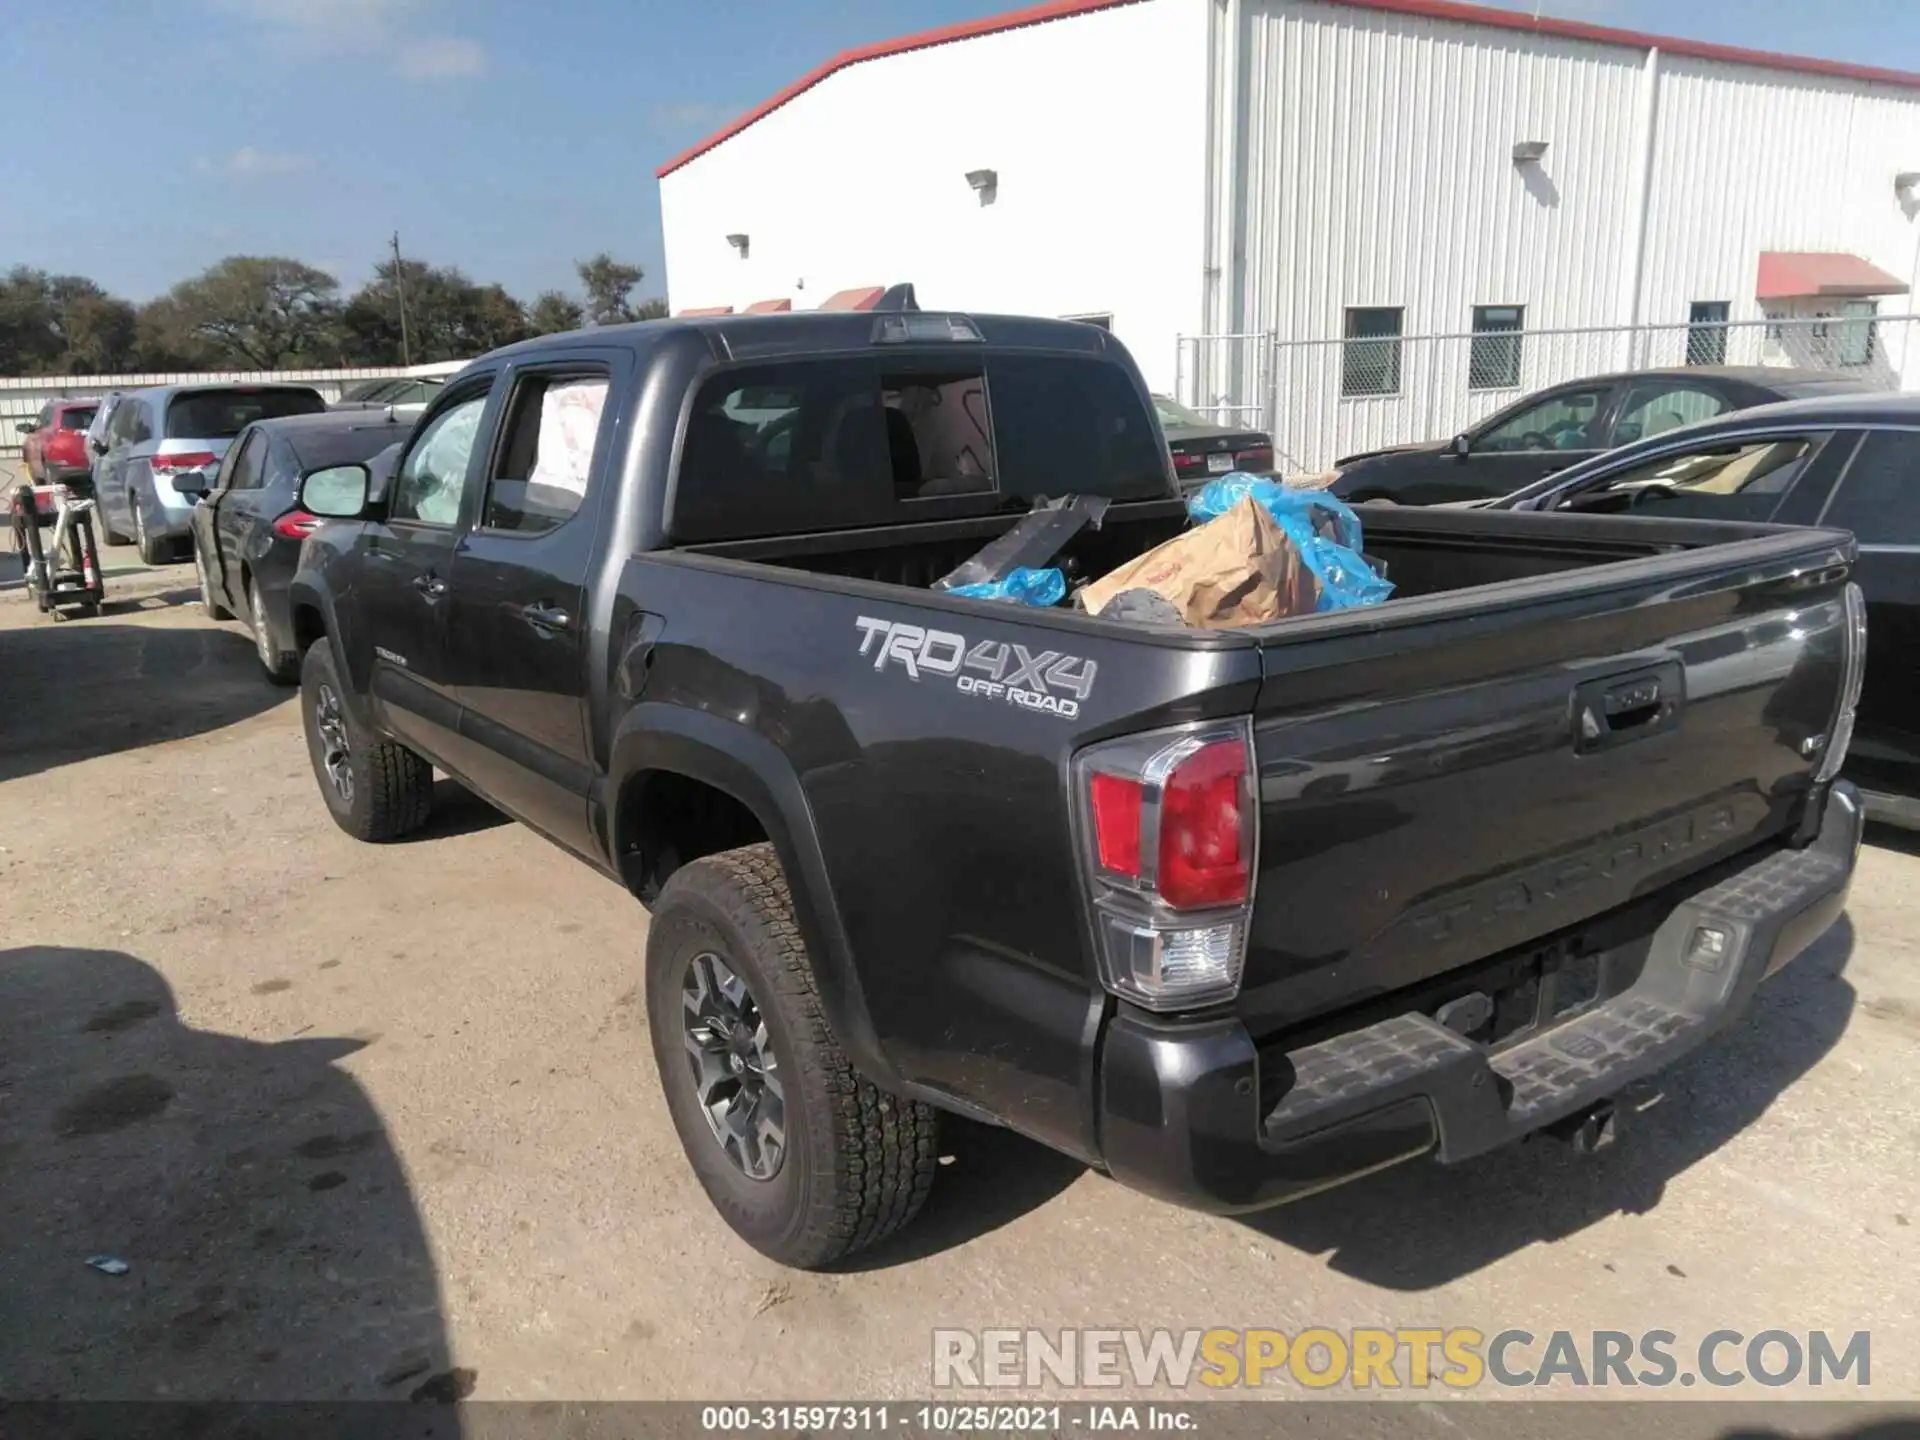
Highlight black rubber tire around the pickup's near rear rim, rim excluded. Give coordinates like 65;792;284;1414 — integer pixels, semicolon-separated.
647;845;939;1269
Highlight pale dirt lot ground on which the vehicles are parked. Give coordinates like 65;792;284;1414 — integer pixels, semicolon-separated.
0;551;1920;1434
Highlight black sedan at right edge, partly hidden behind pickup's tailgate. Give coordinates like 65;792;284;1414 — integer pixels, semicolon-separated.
1490;394;1920;828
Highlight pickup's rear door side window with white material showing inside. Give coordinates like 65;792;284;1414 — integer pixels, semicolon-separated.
480;372;609;534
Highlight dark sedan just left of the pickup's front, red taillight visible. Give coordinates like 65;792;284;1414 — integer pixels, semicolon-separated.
190;411;413;685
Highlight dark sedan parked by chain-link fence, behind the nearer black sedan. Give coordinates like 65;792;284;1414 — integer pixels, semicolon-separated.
1332;365;1870;505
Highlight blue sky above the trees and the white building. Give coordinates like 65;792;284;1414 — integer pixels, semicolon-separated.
0;0;1920;300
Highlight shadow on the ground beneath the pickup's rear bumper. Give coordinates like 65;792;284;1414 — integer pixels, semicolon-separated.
1244;916;1855;1290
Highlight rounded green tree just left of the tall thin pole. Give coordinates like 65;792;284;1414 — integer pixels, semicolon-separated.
169;255;340;371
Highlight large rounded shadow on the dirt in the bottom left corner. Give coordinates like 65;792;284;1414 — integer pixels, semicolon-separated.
0;947;474;1413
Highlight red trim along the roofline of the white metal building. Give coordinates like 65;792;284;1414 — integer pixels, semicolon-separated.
655;0;1920;180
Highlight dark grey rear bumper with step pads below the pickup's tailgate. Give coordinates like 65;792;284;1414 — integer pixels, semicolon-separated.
1098;783;1862;1213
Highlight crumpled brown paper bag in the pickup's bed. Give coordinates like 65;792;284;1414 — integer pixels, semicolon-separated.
1081;497;1319;630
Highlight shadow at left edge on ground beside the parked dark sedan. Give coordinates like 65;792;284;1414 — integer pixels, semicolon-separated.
0;620;292;780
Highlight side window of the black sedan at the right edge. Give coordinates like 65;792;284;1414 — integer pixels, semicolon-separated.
1555;436;1826;520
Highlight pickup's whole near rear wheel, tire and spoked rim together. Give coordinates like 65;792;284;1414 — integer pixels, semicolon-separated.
647;845;939;1269
